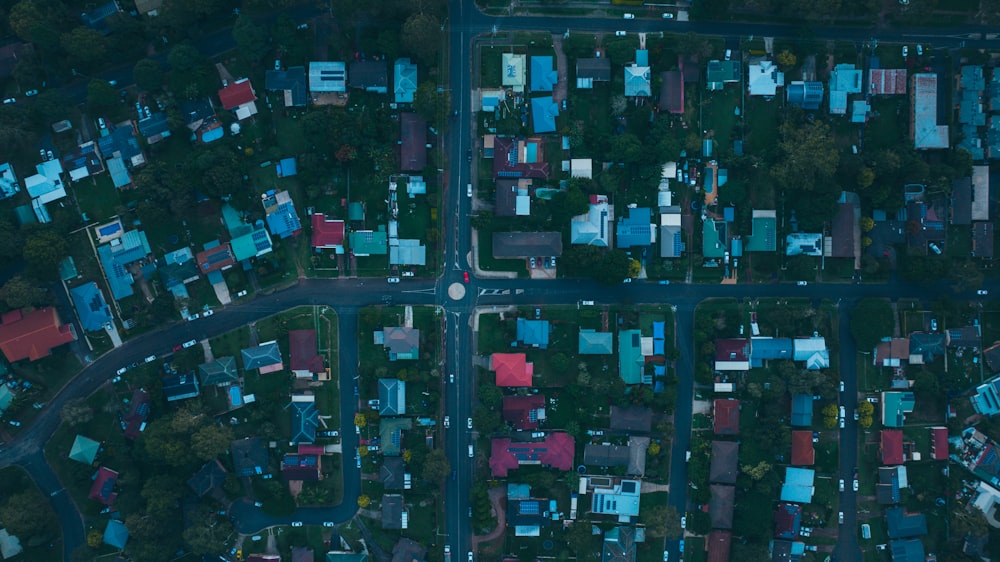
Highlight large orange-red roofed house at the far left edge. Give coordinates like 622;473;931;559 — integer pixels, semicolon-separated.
0;307;76;363
